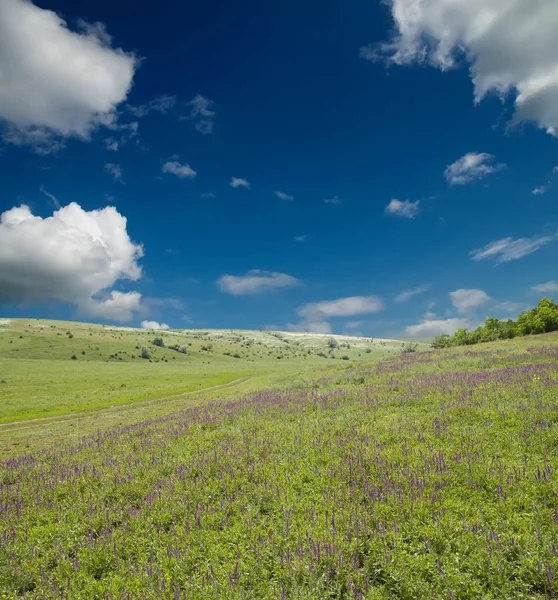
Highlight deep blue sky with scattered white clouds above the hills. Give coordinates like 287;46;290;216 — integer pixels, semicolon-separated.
0;0;558;336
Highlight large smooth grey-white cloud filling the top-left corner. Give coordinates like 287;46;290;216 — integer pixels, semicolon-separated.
0;0;138;154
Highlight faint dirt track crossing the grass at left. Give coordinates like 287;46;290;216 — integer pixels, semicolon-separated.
0;377;253;434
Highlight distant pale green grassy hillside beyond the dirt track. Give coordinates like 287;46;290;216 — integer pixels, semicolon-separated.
0;319;420;426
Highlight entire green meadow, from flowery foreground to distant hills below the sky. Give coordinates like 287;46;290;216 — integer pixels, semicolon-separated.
0;321;558;600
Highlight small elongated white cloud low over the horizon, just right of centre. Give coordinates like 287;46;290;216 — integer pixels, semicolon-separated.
298;296;384;333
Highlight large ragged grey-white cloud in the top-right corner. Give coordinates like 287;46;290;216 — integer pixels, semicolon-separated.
361;0;558;134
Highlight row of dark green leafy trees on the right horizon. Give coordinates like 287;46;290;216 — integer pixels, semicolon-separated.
438;298;558;348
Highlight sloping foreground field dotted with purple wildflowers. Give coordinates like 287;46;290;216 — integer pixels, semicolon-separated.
0;334;558;600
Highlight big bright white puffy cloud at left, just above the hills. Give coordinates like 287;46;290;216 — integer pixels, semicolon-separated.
0;203;147;320
